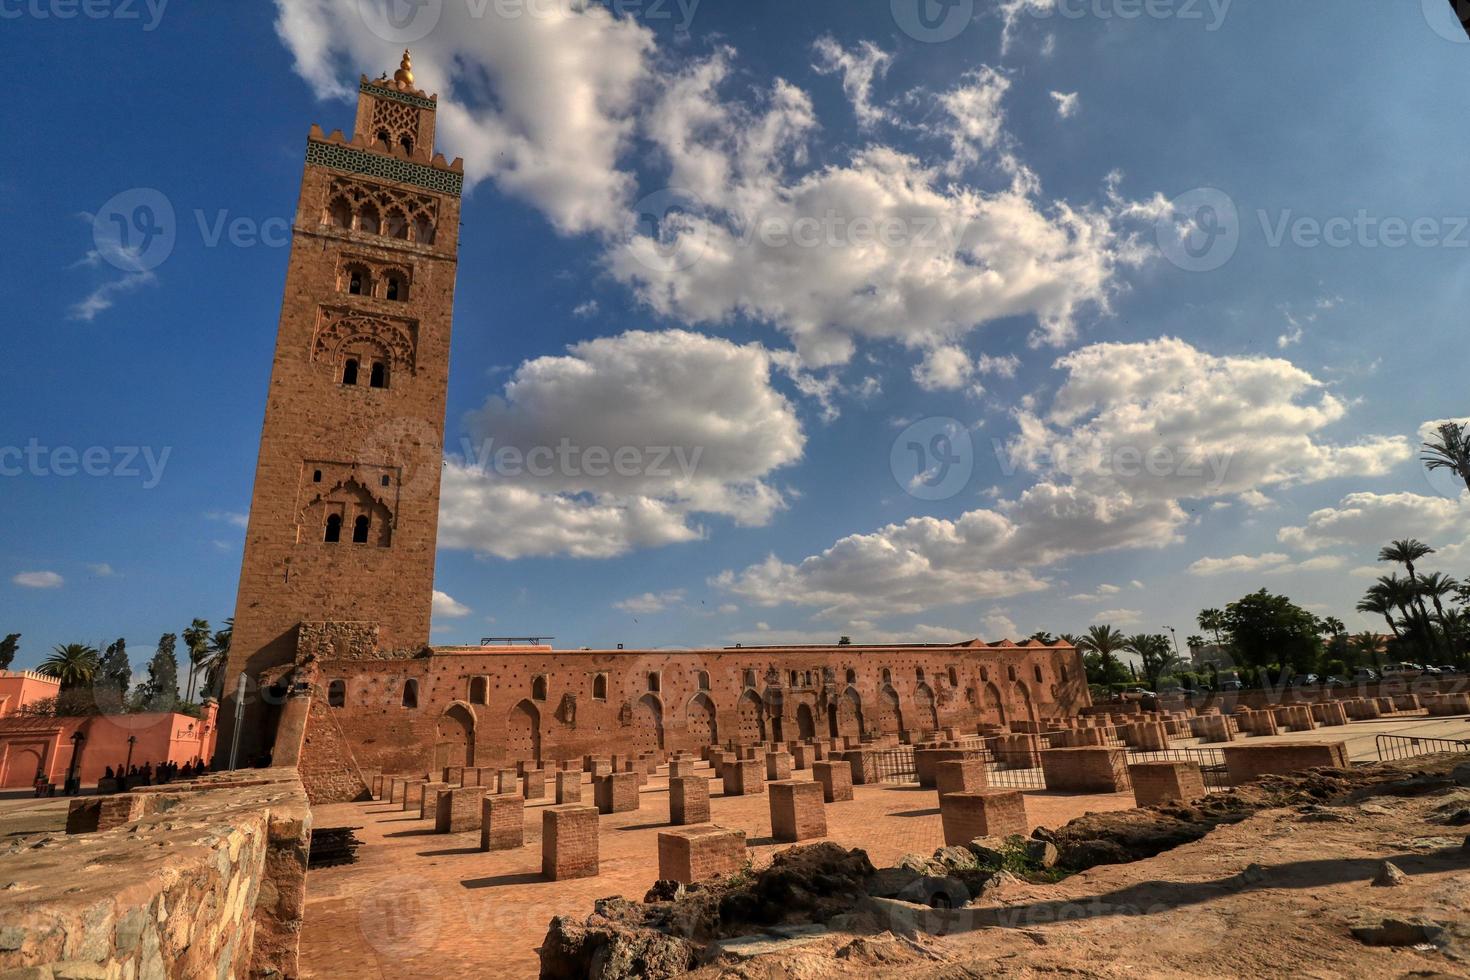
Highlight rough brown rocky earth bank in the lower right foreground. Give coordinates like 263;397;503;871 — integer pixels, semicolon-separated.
541;755;1470;980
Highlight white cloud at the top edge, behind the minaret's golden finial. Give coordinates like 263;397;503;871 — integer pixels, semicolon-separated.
276;0;654;232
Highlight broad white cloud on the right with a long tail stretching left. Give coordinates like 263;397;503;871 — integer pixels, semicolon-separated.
714;338;1410;619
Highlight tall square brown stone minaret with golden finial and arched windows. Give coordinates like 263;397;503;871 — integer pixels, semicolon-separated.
219;51;465;765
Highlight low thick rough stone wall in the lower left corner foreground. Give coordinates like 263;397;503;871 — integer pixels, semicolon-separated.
0;770;312;979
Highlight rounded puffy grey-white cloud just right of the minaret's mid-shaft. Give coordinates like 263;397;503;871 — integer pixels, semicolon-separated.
440;331;806;558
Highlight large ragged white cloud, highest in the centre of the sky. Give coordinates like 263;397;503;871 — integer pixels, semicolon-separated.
607;50;1147;367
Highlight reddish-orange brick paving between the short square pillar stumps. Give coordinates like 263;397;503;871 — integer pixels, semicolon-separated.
292;764;1133;979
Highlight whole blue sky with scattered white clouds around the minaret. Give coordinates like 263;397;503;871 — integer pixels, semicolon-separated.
0;0;1470;675
